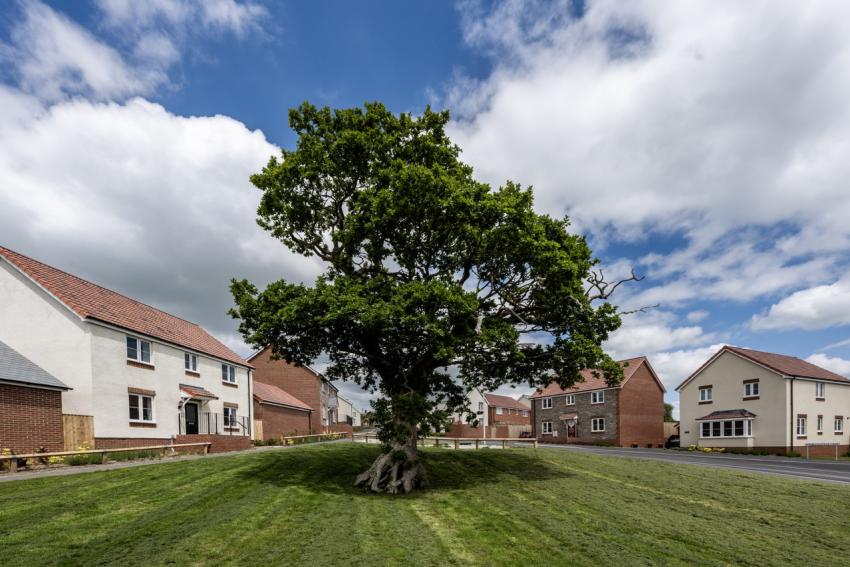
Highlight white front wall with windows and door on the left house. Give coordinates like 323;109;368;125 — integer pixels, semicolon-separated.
90;324;250;438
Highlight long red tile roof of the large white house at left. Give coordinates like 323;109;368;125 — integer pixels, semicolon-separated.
0;246;250;366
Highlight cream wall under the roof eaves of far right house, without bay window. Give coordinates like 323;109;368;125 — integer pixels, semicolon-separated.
788;378;850;452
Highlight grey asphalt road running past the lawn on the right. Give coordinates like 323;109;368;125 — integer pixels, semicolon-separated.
540;444;850;485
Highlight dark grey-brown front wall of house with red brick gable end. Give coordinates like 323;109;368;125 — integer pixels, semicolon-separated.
533;390;620;445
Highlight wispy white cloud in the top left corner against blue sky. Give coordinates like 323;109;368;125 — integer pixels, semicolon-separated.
0;2;166;101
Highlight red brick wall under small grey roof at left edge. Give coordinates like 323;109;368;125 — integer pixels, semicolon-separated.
0;384;65;453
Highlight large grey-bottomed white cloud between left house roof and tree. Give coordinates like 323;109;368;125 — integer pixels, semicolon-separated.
0;91;320;354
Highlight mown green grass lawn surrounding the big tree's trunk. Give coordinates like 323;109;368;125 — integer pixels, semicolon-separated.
0;443;850;567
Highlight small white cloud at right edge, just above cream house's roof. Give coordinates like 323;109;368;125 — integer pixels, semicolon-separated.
751;278;850;330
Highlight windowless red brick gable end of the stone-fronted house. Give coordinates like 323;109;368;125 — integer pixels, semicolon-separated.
620;364;666;447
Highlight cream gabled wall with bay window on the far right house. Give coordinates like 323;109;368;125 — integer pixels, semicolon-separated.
679;351;784;447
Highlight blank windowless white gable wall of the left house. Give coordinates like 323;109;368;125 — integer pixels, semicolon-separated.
0;258;93;415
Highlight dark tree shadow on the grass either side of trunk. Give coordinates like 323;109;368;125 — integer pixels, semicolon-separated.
239;443;572;493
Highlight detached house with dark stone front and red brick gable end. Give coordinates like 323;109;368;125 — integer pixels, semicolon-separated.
531;356;665;447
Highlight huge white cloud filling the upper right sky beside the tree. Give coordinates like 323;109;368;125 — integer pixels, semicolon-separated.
446;0;850;306
